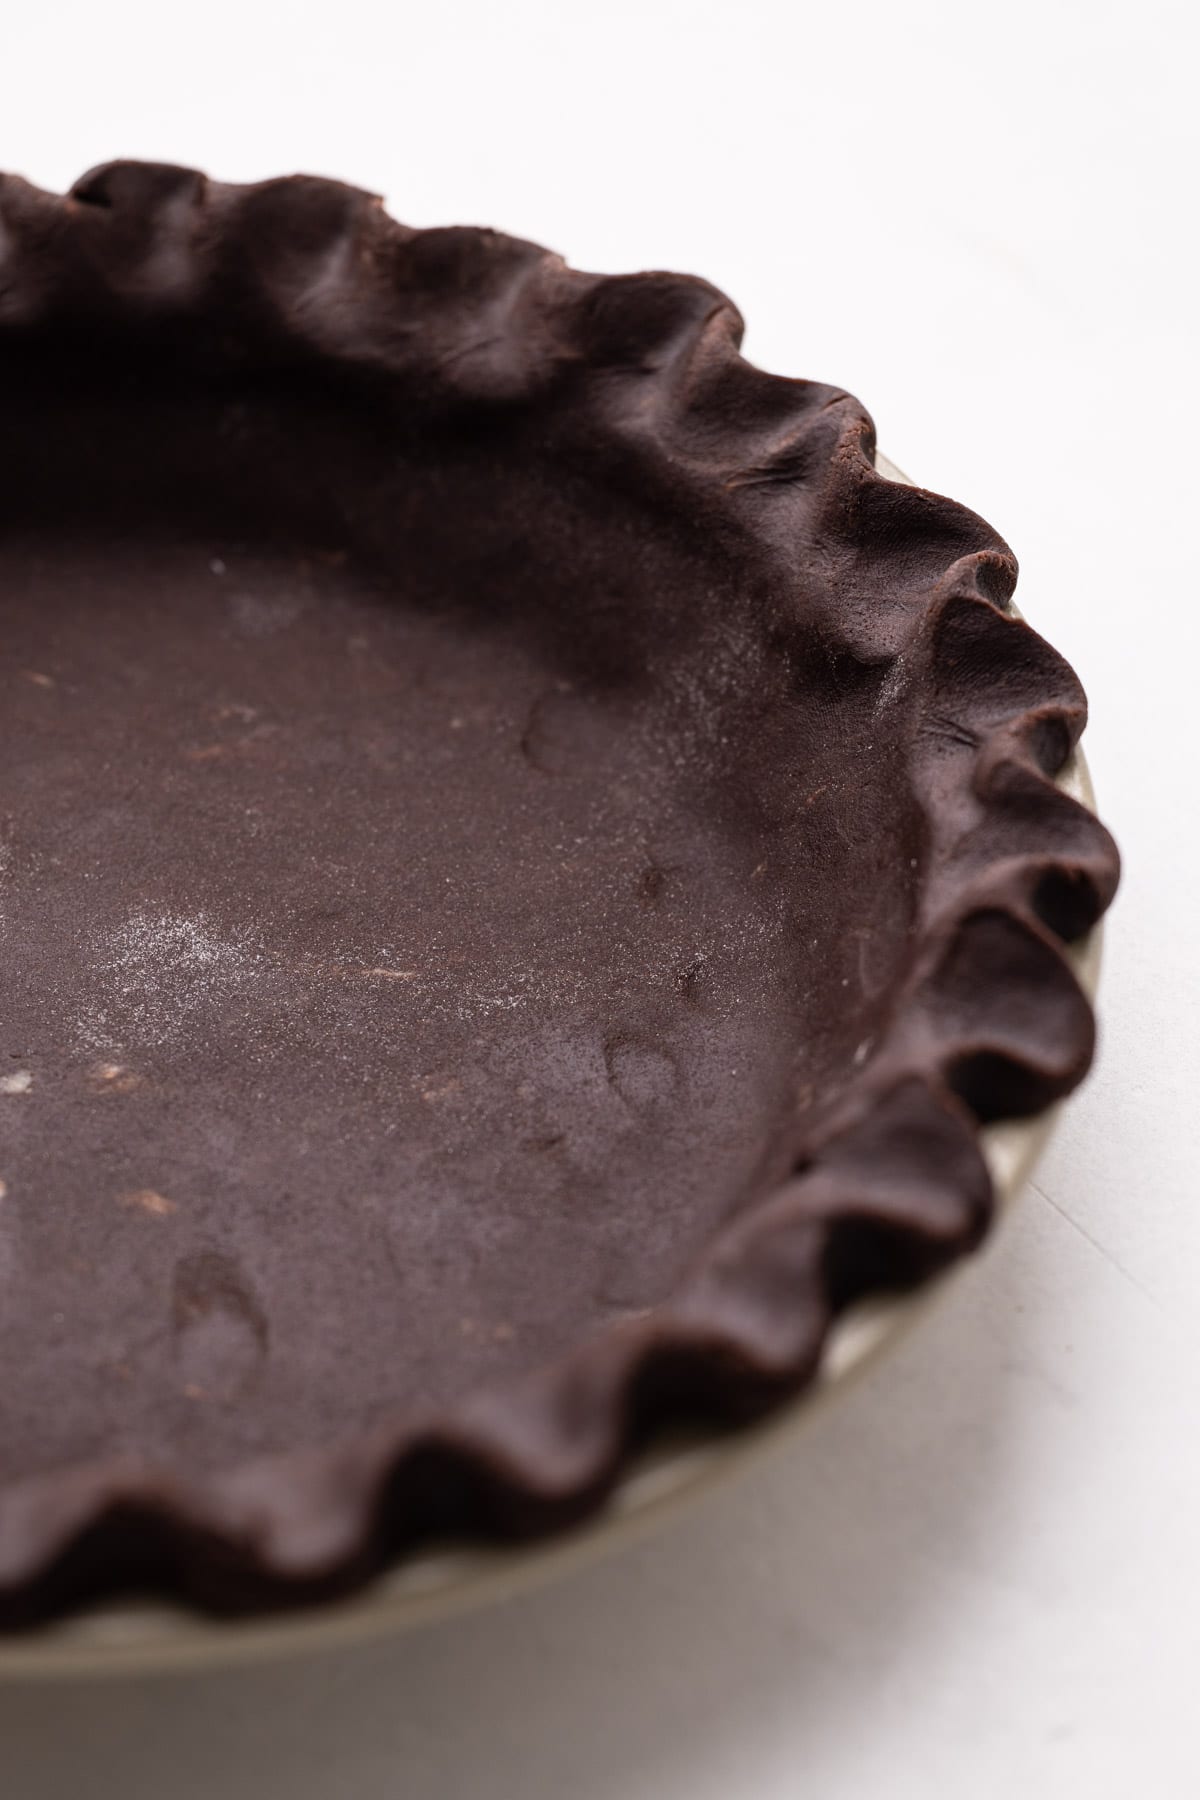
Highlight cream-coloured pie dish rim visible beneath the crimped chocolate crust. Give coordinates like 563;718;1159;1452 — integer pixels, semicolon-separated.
0;455;1103;1681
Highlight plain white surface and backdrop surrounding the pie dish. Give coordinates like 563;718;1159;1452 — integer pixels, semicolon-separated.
0;0;1200;1800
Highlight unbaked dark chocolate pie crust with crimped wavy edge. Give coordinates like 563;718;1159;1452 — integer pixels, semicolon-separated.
0;164;1117;1631
